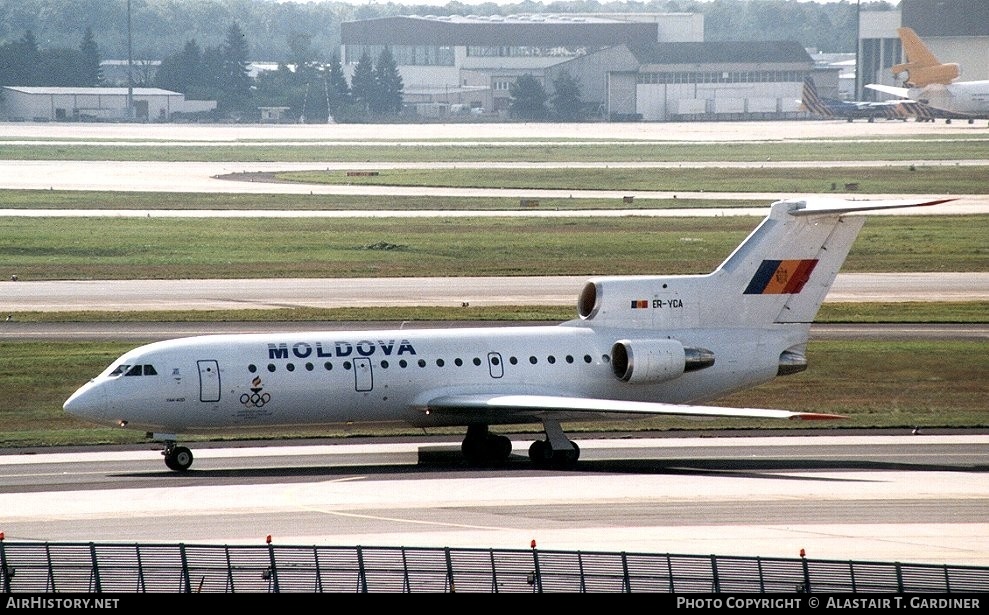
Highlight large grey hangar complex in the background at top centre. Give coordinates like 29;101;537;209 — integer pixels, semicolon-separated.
341;13;814;121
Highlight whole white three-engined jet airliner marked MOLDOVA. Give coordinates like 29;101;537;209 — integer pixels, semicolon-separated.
64;199;950;471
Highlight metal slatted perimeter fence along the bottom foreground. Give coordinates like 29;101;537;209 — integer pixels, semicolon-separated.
0;542;989;594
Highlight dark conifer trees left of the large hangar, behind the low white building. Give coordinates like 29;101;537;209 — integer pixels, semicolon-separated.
0;22;404;123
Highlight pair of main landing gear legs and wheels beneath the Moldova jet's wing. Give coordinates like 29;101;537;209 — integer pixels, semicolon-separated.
460;419;580;468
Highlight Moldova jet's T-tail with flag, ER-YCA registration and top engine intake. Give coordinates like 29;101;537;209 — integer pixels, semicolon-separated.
578;199;952;331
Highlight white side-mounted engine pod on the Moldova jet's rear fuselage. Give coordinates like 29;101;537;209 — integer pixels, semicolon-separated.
611;339;714;384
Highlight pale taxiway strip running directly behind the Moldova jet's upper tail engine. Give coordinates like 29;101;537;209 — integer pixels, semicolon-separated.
0;272;989;312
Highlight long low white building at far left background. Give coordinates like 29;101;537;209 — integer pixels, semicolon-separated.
0;86;216;122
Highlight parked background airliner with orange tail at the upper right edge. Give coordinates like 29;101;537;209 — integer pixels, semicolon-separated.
865;27;989;123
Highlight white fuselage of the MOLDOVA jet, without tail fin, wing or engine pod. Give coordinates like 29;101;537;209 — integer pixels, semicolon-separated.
66;323;806;433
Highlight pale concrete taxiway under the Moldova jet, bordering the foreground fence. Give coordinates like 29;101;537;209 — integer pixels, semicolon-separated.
0;433;989;566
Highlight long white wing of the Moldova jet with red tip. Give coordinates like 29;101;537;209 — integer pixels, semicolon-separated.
424;394;845;423
